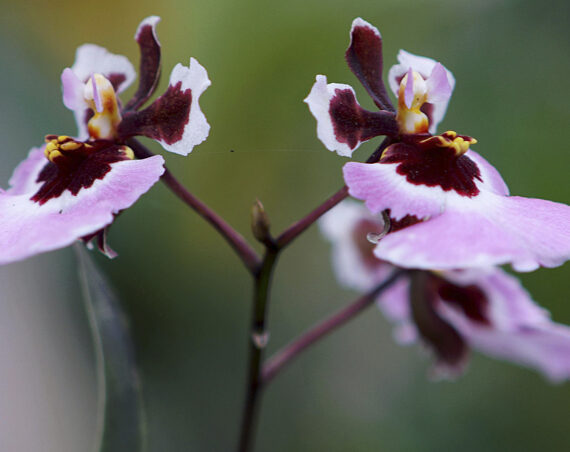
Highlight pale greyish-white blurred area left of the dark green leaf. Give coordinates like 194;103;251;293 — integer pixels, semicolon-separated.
0;252;96;452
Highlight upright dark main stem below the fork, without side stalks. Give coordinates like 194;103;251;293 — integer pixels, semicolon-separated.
238;246;279;452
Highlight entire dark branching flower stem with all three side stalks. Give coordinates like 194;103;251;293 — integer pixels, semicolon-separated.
127;133;392;452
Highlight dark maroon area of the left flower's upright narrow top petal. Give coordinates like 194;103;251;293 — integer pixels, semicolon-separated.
125;24;161;110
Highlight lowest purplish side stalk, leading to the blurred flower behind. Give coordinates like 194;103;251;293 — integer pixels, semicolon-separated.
261;270;405;386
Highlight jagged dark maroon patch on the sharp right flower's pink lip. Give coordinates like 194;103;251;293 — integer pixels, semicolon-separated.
379;143;481;197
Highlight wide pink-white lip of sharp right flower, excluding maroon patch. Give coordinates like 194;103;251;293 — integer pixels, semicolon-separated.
343;140;570;271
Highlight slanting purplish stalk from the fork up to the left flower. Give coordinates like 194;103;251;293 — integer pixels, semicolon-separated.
127;138;260;273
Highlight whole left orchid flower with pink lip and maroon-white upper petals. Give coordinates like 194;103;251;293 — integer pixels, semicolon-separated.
0;16;210;264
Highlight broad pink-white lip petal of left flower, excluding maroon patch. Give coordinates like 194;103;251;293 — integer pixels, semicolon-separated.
0;151;164;264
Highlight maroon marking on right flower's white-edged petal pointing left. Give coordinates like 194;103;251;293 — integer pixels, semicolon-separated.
329;89;398;149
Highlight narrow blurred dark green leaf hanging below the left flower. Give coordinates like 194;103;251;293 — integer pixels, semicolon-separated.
75;245;146;452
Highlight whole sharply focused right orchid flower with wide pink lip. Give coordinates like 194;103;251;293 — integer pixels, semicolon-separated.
305;19;570;271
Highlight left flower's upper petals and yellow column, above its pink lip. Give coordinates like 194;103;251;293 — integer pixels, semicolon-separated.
61;16;210;155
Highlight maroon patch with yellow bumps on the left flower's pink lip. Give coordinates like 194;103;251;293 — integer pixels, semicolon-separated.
31;136;132;205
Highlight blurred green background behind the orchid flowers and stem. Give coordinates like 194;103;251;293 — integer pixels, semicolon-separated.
0;0;570;452
